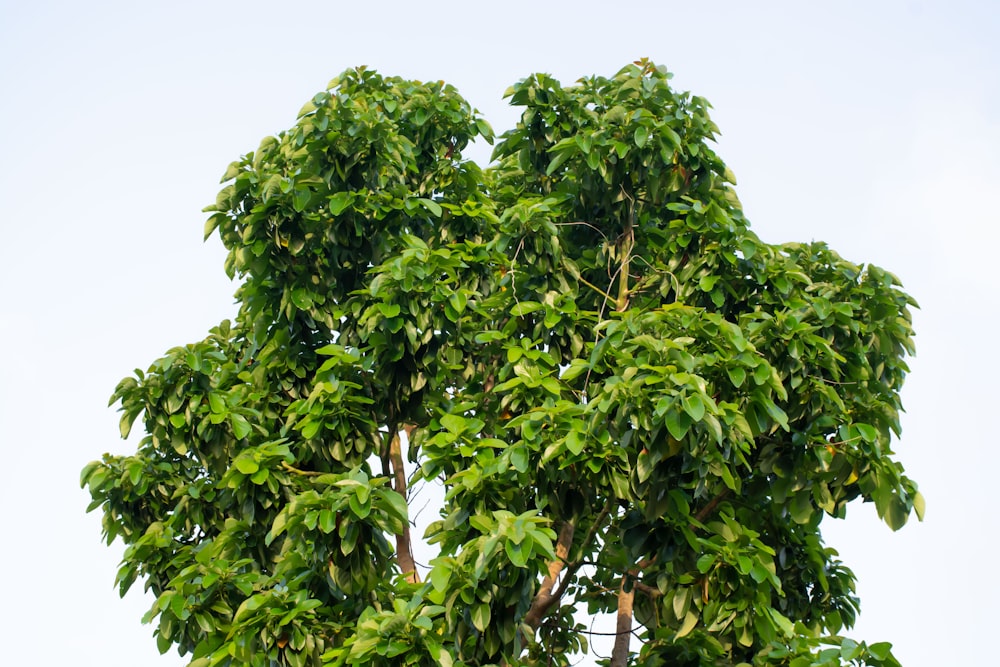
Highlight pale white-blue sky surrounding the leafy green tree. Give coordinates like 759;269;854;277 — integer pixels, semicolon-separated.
0;0;1000;667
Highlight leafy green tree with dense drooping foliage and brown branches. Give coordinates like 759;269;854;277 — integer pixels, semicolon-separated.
82;60;923;667
